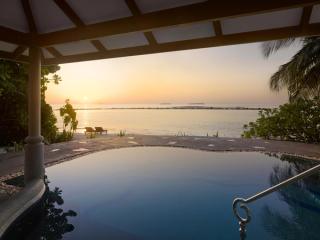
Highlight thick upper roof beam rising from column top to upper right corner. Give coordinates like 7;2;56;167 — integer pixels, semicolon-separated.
37;0;320;46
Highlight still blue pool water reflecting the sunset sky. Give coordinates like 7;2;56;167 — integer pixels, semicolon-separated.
5;147;320;240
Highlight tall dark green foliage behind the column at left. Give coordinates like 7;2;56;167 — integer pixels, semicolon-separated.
0;60;61;145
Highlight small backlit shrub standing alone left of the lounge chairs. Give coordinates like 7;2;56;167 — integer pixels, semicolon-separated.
58;99;78;140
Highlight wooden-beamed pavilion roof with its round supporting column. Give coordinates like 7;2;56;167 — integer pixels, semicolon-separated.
0;0;320;237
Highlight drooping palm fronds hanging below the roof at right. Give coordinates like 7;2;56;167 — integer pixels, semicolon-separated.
262;37;320;101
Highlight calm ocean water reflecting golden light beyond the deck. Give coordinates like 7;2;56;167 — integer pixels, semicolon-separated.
53;104;272;137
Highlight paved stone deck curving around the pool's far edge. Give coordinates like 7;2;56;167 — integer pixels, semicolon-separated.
0;134;320;201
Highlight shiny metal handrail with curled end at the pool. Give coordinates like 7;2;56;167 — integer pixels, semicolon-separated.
232;164;320;239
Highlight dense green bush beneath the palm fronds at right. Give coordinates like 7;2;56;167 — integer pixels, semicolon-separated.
242;98;320;143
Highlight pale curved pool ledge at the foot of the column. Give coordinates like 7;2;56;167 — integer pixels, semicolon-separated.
0;179;46;239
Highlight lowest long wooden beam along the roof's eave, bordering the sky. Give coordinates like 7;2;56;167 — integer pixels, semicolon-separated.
44;24;320;65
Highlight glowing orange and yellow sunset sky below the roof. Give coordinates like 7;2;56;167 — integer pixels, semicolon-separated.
47;43;298;104
